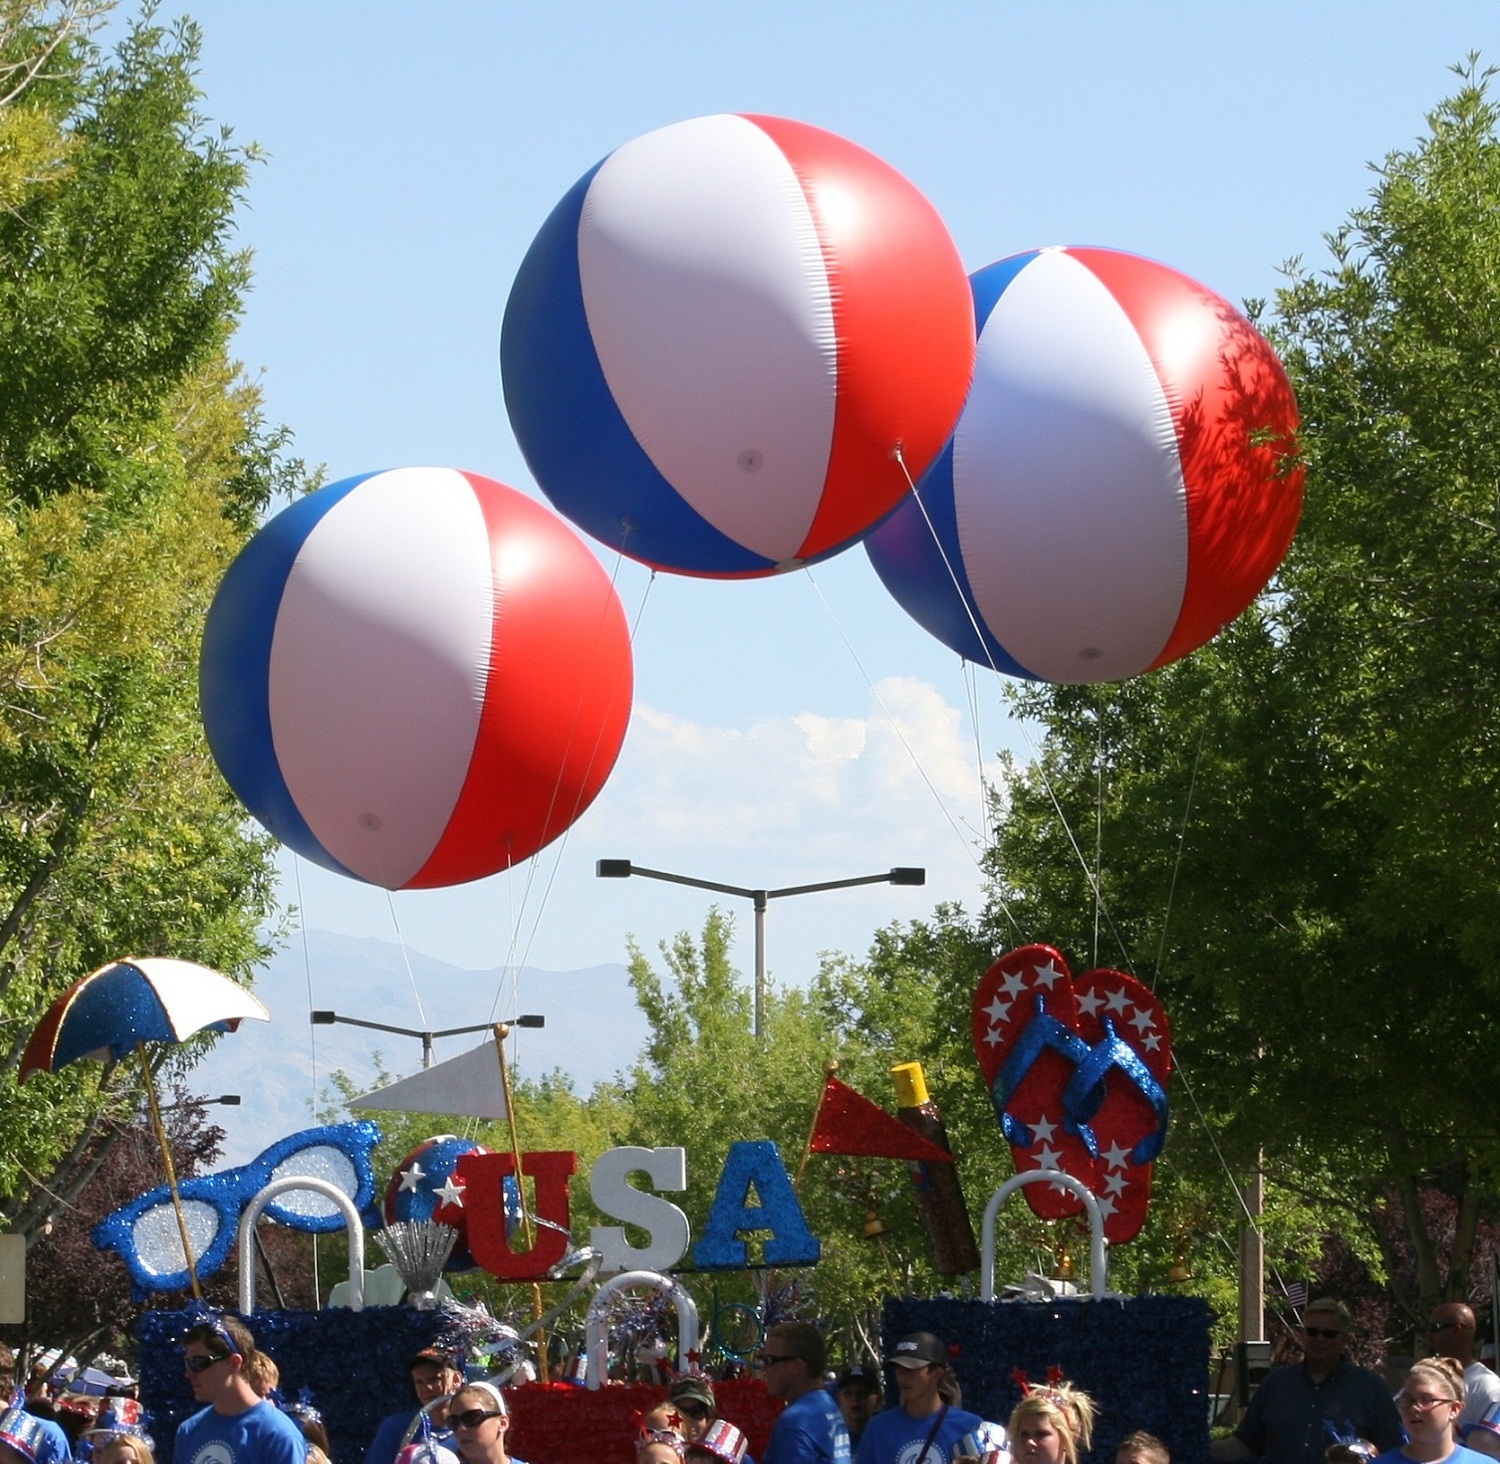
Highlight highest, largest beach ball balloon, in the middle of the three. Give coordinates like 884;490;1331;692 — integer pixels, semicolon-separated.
501;116;974;576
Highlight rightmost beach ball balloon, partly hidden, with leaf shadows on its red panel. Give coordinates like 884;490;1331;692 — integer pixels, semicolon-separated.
866;249;1302;683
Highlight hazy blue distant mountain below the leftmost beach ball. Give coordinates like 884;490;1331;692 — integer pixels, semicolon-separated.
189;930;647;1164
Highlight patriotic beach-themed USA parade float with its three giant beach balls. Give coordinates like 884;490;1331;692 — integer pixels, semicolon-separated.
17;116;1301;1464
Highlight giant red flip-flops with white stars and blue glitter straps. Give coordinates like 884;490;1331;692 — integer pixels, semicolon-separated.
974;945;1172;1245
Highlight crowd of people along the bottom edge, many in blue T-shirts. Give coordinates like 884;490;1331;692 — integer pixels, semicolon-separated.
0;1299;1500;1464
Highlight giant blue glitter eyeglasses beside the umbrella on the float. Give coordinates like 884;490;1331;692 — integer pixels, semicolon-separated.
93;1119;380;1299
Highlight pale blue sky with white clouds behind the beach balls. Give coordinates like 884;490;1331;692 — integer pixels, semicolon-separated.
164;0;1500;1022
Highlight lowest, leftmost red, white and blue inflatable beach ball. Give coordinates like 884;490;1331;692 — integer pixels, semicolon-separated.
200;468;632;890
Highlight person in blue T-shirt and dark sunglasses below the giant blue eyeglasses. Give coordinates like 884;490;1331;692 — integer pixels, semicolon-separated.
173;1317;308;1464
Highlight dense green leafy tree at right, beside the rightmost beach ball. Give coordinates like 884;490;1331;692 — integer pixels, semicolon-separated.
960;63;1500;1338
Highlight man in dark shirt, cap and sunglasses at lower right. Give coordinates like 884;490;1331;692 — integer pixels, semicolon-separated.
1209;1298;1403;1464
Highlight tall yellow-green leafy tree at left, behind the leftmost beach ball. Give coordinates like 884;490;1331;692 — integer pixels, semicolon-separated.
0;0;303;1236
